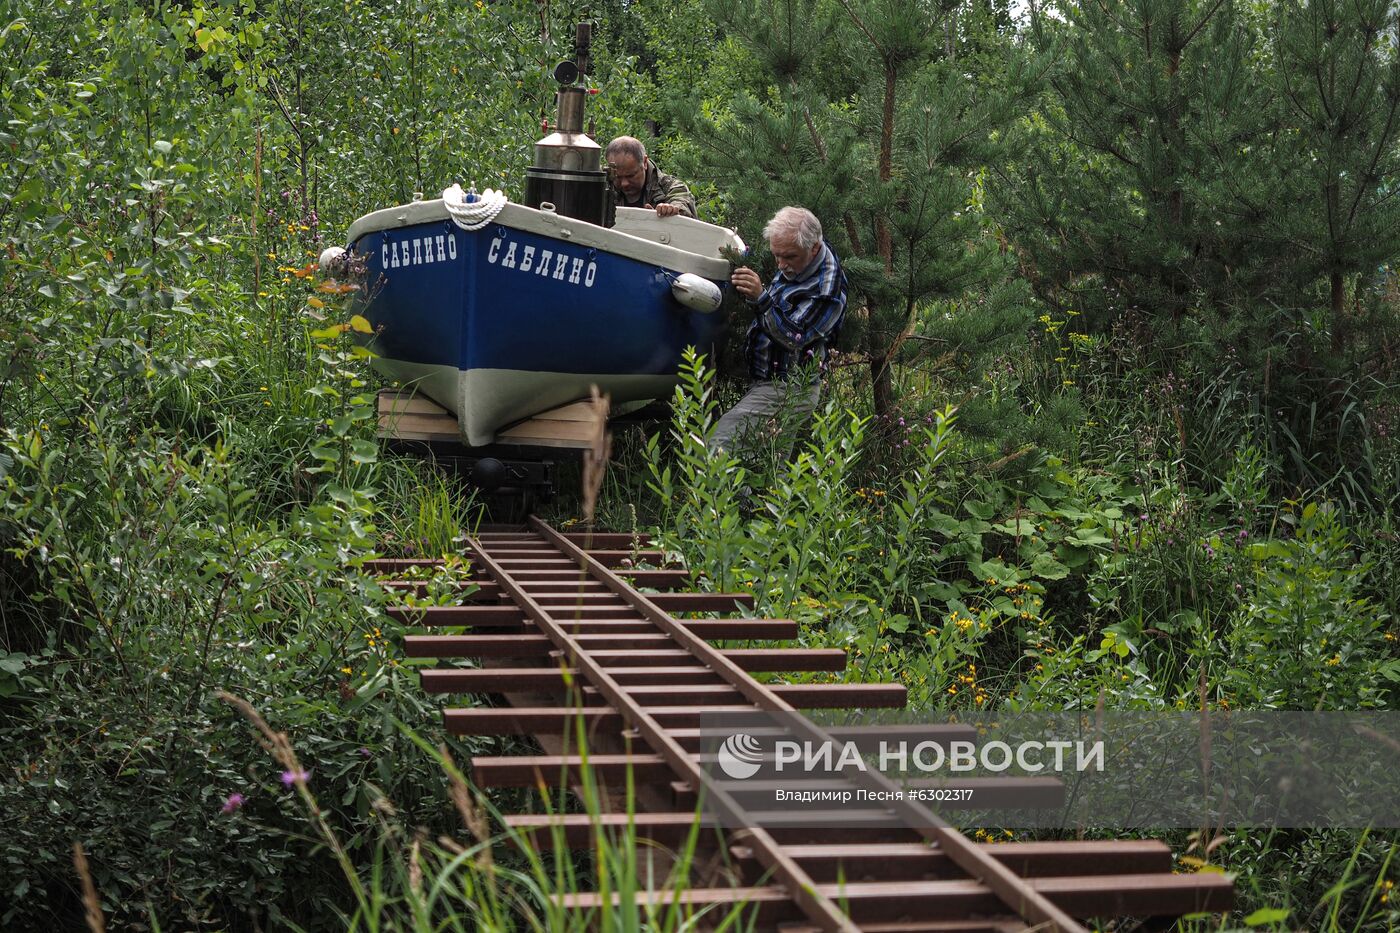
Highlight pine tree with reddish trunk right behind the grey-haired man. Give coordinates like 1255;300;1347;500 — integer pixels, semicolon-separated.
689;0;1015;415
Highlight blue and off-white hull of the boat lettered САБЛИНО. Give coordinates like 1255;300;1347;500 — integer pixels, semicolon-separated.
350;202;732;445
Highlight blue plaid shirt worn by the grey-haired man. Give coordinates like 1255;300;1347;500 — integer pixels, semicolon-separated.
743;241;846;380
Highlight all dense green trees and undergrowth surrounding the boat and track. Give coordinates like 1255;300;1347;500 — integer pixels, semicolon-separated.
0;0;1400;930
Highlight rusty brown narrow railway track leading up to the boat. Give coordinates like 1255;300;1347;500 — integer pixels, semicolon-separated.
368;518;1233;933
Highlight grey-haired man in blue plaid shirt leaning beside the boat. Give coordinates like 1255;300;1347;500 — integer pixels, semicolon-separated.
710;207;846;450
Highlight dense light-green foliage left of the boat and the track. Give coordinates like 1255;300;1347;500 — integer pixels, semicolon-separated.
0;3;635;929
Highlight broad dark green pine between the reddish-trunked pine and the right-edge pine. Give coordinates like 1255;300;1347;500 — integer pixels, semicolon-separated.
991;0;1273;326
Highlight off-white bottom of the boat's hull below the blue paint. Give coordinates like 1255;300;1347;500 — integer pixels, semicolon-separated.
374;357;676;447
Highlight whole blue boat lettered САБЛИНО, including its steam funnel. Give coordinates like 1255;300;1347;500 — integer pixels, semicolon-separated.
322;27;743;447
